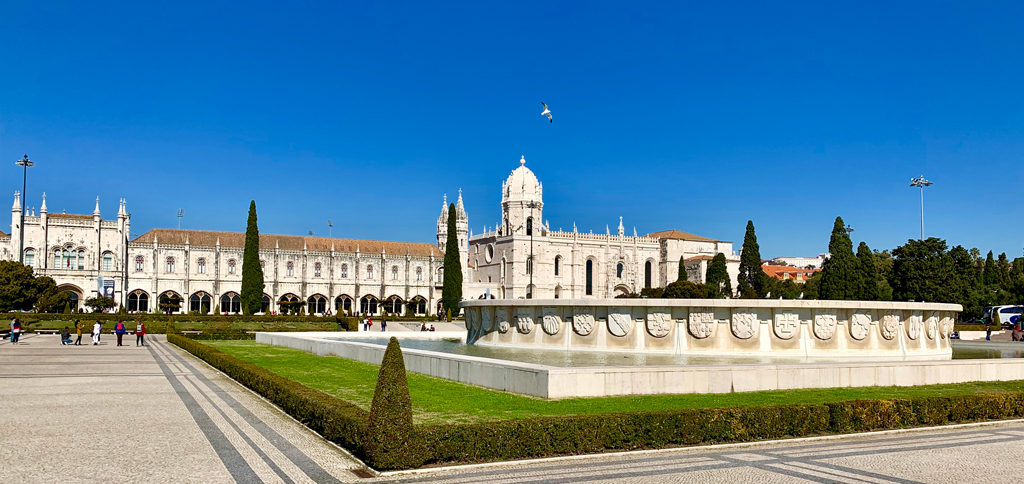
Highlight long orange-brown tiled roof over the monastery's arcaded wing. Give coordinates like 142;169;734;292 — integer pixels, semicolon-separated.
132;228;443;257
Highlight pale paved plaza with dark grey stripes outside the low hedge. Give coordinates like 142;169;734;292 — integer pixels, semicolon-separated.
0;335;1024;483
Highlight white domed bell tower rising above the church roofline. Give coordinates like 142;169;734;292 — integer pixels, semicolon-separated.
502;157;544;235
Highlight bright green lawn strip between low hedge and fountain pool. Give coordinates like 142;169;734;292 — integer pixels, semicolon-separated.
203;341;1024;424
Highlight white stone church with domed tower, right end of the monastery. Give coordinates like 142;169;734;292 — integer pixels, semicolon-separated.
464;158;739;299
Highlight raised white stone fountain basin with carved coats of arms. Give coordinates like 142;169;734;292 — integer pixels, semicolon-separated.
462;299;963;359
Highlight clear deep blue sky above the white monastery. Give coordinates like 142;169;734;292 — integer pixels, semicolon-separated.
0;0;1024;257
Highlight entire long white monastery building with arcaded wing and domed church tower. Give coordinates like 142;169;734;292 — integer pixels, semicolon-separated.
0;158;739;314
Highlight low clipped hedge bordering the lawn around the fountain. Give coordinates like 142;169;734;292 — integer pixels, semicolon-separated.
168;335;1024;470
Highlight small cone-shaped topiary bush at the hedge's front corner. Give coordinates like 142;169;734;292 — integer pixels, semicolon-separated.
364;337;423;470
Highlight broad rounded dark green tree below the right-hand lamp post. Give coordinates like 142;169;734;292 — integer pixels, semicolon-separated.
892;237;964;303
